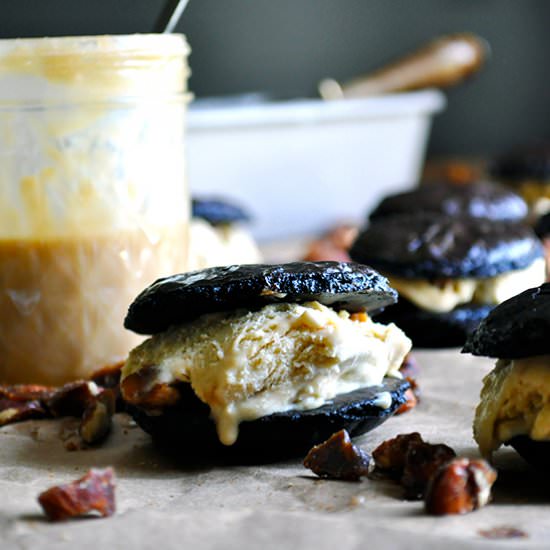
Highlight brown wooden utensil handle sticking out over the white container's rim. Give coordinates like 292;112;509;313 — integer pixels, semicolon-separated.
319;33;489;99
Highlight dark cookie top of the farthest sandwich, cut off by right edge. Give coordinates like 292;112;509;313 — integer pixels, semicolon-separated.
489;143;550;181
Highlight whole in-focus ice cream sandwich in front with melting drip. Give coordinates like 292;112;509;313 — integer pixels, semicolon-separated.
121;262;411;460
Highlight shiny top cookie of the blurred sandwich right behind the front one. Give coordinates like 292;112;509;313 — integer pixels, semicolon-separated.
350;213;543;279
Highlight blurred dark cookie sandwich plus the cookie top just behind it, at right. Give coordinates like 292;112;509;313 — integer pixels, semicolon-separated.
350;182;545;347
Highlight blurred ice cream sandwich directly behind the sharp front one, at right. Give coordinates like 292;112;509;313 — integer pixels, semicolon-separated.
350;213;545;347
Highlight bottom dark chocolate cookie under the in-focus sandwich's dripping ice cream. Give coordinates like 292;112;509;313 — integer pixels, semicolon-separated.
128;378;409;463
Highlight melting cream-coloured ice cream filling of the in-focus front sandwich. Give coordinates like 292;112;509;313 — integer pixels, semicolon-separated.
122;302;411;445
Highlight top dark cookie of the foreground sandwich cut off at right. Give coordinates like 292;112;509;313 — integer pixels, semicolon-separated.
462;283;550;359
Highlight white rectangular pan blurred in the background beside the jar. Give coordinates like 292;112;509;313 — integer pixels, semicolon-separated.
187;90;445;241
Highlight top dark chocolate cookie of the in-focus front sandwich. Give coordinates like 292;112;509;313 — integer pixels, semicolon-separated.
124;262;397;334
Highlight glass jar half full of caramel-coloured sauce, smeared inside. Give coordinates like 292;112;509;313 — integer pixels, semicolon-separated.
0;35;189;384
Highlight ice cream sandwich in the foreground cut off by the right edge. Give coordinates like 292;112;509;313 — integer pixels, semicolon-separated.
462;283;550;468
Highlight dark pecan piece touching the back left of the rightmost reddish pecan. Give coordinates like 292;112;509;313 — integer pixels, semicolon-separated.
401;441;456;499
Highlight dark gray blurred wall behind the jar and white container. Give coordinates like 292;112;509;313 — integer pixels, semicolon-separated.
0;0;550;155
